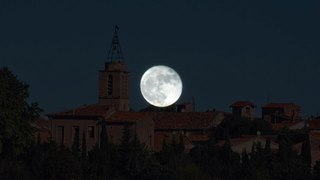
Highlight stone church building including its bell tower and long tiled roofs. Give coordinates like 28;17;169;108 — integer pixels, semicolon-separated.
43;28;225;151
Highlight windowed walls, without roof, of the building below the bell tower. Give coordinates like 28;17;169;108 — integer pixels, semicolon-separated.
52;115;154;150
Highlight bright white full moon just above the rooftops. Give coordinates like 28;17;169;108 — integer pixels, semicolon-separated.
140;65;182;107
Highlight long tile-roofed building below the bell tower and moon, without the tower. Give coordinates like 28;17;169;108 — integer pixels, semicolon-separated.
47;107;225;151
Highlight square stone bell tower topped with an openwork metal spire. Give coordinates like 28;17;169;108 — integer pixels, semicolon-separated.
99;26;130;111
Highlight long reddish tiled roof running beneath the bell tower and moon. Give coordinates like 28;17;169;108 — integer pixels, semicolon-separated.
48;104;225;130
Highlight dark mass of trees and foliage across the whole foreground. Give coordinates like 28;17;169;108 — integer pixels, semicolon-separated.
0;68;320;180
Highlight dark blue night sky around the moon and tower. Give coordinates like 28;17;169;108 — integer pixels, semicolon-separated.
0;0;320;116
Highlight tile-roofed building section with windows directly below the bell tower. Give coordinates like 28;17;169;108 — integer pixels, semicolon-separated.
47;104;154;150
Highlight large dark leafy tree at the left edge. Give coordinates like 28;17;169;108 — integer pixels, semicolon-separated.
0;68;41;157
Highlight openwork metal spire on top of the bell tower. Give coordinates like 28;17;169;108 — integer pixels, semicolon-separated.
108;25;123;61
